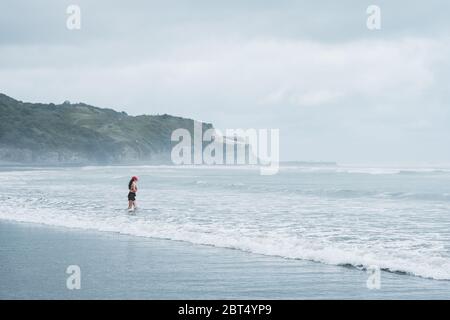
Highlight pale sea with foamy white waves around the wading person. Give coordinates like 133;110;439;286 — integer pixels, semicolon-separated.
0;166;450;280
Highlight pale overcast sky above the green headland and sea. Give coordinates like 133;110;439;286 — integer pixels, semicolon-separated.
0;0;450;165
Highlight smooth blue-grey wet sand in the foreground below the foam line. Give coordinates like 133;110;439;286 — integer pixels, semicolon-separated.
0;220;450;300
